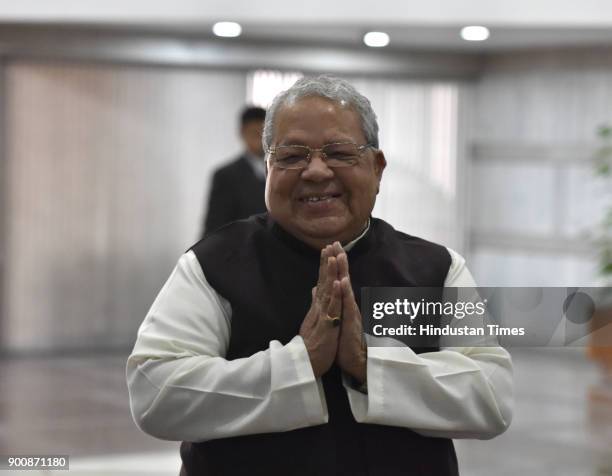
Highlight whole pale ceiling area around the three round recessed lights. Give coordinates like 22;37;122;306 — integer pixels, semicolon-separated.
0;0;612;52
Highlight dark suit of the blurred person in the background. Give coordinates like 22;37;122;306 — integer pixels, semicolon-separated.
202;155;266;234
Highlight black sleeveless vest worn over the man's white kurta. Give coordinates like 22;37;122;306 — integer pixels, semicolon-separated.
181;214;458;476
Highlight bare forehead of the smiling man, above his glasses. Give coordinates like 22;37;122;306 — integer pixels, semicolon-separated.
273;97;365;146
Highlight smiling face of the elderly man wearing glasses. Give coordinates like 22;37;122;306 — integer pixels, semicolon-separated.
266;97;386;248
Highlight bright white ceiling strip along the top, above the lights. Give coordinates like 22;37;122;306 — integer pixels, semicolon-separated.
5;0;612;27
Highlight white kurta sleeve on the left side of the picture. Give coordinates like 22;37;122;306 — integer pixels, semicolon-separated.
126;251;328;442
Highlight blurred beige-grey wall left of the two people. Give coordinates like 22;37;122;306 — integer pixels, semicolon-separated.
3;61;245;350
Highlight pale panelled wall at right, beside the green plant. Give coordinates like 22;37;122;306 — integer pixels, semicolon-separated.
469;48;612;286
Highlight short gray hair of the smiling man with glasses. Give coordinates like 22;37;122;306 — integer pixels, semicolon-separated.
262;74;378;151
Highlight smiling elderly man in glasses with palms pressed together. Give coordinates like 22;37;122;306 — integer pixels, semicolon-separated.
127;76;512;476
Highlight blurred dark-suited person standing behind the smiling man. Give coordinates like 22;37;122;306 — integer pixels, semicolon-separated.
202;107;266;236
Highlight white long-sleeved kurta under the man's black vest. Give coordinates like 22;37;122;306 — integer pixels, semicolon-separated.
127;250;513;442
